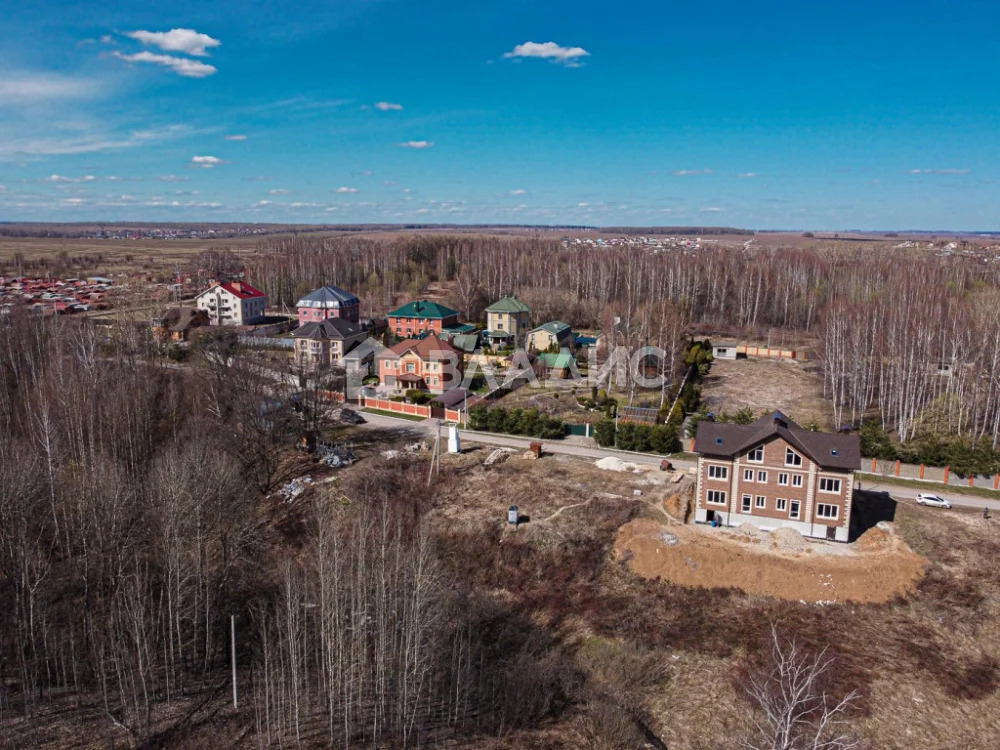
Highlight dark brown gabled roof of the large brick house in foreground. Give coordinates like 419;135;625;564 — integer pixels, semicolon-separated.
694;411;861;470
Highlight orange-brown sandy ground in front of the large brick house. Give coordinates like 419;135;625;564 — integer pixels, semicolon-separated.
615;519;926;602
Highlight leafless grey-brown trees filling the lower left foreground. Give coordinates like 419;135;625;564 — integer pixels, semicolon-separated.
0;315;572;747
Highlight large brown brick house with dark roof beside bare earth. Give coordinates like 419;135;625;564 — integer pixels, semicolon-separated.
694;412;861;542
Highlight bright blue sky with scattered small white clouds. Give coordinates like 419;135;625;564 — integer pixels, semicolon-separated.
0;0;1000;230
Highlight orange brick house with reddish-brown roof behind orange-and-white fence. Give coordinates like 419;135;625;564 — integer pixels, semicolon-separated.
375;334;462;393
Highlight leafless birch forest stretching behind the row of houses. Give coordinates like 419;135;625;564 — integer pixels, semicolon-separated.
242;236;1000;447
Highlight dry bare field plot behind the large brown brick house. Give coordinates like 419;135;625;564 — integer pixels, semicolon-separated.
702;359;835;429
